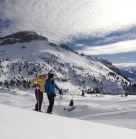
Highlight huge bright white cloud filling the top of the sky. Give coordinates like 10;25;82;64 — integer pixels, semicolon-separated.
0;0;136;42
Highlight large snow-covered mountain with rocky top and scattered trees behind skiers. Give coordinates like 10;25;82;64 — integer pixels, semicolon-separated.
0;31;135;94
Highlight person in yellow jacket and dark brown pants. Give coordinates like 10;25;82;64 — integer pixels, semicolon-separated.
31;74;47;112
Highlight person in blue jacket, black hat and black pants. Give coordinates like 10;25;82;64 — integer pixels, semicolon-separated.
45;73;63;114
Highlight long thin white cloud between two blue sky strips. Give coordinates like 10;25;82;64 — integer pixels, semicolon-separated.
78;40;136;55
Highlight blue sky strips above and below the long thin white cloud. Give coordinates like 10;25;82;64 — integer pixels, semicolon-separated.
67;27;136;63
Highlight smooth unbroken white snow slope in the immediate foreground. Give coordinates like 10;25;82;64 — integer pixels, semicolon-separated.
0;104;136;139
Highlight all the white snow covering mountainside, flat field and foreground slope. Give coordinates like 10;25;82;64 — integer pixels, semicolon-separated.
0;38;136;139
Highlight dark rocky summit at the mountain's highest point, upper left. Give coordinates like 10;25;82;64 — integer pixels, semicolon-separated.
0;31;48;45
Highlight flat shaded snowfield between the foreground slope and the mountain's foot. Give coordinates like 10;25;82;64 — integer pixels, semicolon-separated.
0;89;136;129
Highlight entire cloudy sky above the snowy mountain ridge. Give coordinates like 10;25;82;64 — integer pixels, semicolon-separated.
0;0;136;63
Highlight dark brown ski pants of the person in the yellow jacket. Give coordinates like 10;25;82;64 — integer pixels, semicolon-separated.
35;89;43;111
